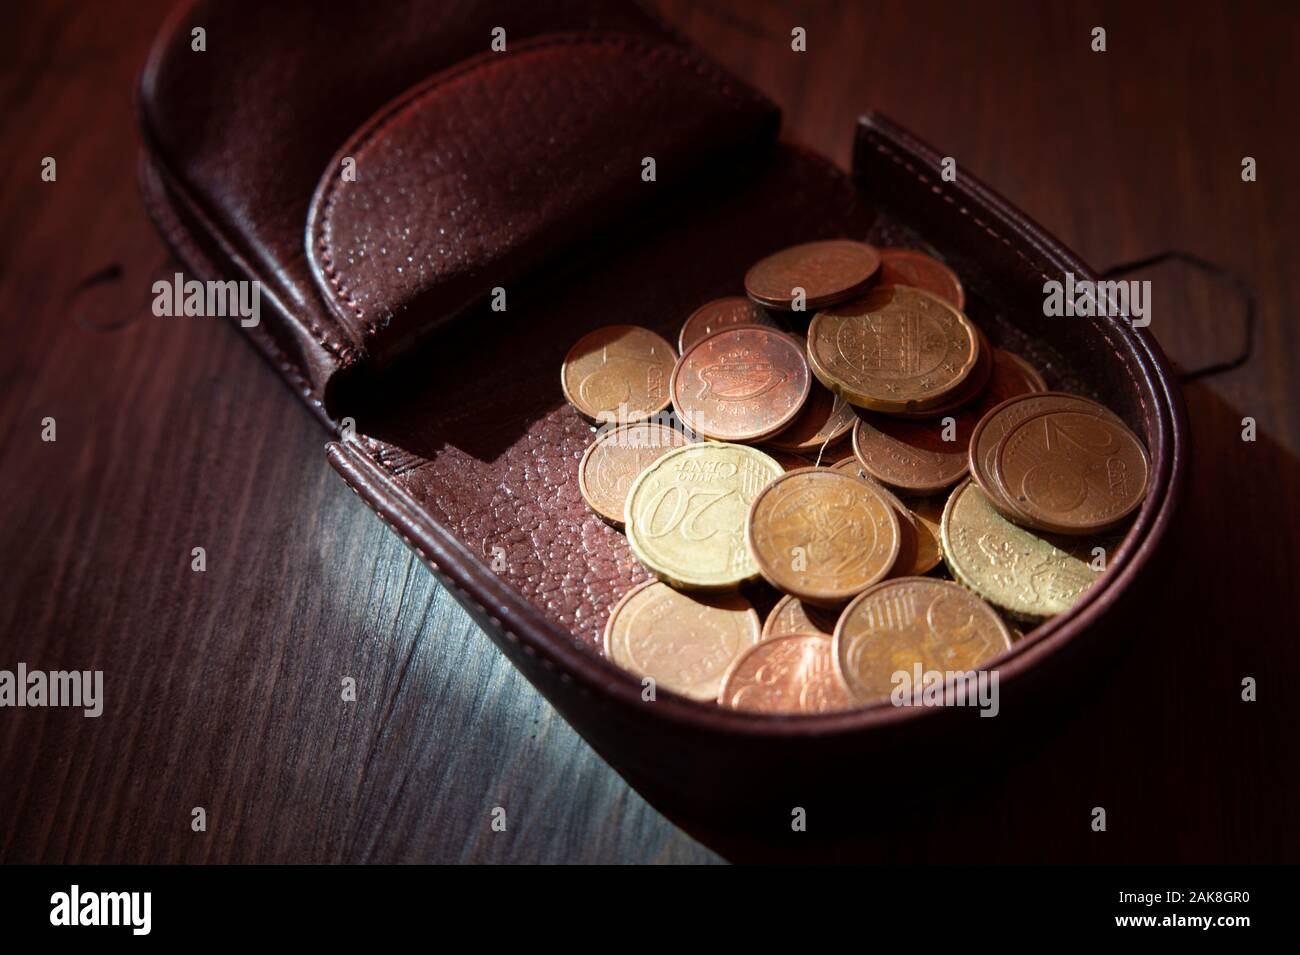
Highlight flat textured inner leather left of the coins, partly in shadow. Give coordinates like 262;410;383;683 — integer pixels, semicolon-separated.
340;147;871;647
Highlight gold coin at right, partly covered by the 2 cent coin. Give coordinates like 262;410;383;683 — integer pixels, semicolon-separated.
941;479;1101;620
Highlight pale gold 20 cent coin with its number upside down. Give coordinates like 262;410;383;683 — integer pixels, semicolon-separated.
625;442;784;590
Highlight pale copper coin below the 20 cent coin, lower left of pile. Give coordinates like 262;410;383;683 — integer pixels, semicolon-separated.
605;581;761;700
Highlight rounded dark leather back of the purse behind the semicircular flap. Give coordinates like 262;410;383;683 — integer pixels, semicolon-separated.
139;0;668;403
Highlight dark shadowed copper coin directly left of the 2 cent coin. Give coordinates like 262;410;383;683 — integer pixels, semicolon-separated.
853;414;969;494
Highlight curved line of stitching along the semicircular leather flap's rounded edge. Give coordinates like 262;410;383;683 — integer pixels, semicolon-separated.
315;35;767;338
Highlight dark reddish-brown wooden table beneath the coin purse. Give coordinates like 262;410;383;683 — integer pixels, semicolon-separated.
0;0;1300;863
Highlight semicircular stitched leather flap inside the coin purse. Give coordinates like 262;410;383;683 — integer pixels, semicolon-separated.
308;34;779;365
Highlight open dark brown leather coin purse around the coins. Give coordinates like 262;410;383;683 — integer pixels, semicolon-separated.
139;0;1187;842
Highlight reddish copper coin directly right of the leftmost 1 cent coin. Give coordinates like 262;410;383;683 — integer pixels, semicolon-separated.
672;325;813;442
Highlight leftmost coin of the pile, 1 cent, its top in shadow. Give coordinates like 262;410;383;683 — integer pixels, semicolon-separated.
560;325;676;424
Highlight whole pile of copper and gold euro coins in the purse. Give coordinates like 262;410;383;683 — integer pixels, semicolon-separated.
562;239;1149;713
